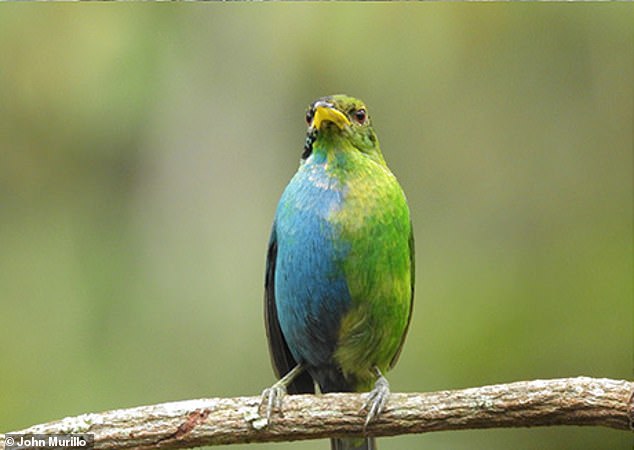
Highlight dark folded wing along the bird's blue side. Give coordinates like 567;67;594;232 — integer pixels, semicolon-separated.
264;224;315;394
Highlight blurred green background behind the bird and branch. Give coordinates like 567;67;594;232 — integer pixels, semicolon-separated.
0;4;634;450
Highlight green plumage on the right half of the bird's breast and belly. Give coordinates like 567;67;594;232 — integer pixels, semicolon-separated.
324;128;414;391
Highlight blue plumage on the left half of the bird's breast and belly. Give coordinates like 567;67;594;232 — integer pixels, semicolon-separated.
275;161;351;386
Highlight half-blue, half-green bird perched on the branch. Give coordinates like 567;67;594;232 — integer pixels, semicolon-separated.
260;94;414;450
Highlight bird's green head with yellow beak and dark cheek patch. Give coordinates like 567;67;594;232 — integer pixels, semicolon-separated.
302;94;385;164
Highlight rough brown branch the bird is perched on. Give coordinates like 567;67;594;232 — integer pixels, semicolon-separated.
0;377;634;449
